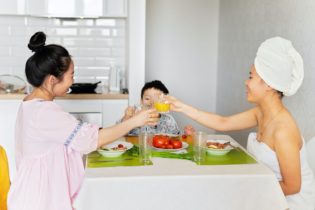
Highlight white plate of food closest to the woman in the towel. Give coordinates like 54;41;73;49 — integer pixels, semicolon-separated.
206;139;235;155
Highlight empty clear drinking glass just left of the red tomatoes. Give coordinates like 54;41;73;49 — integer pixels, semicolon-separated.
139;133;153;165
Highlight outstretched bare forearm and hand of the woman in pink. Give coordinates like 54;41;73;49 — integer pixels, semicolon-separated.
97;109;159;148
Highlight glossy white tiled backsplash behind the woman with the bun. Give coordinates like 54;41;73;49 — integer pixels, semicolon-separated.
0;16;126;88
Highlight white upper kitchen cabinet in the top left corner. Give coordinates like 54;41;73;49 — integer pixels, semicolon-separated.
0;0;26;15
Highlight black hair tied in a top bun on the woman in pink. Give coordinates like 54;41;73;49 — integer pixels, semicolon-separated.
25;32;71;87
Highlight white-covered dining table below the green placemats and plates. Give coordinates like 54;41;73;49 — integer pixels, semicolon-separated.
74;135;288;210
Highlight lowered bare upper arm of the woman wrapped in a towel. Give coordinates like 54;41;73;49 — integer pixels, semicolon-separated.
274;126;302;195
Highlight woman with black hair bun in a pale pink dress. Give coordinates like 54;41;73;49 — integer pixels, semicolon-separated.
8;32;158;210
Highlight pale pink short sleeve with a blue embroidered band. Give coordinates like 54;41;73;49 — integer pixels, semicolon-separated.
34;102;99;154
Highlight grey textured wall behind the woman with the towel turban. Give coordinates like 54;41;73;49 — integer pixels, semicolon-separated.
217;0;315;144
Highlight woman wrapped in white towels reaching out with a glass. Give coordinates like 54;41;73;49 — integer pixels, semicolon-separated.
168;37;315;210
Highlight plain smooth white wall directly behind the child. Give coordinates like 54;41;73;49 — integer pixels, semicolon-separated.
146;0;219;131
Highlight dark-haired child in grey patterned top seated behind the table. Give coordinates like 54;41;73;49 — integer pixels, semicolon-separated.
121;80;180;135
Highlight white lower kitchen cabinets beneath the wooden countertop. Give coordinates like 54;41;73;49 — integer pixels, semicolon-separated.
0;99;128;179
